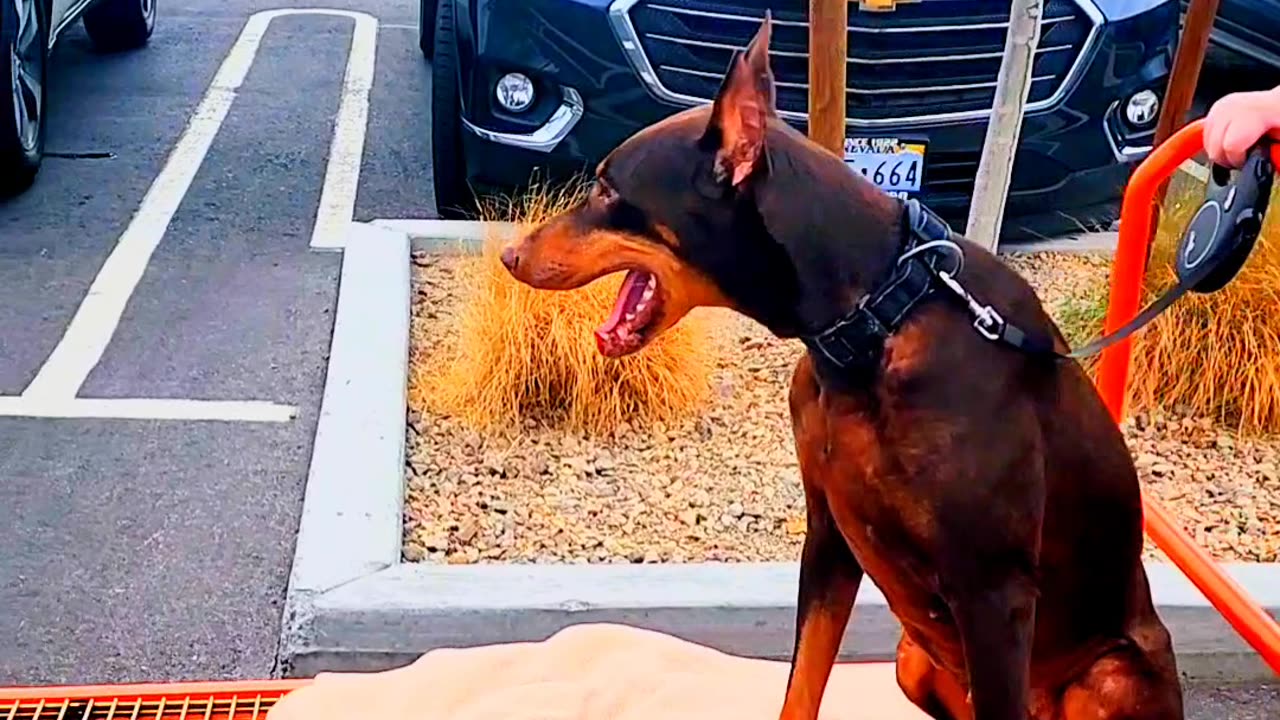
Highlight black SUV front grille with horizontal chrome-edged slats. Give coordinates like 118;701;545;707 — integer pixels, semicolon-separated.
611;0;1096;126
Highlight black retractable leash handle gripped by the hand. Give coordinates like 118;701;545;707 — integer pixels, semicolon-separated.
1175;141;1276;293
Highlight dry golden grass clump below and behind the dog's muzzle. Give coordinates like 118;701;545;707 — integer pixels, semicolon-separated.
410;184;714;434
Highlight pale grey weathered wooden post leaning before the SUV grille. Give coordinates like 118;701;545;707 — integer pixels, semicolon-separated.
965;0;1043;252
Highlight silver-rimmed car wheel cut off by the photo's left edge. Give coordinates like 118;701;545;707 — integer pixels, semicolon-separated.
0;0;49;196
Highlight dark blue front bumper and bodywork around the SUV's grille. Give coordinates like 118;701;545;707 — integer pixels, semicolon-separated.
452;0;1179;233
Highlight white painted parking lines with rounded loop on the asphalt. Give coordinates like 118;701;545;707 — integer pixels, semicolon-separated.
11;8;378;421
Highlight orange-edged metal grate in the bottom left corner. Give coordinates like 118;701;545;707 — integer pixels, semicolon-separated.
0;682;301;720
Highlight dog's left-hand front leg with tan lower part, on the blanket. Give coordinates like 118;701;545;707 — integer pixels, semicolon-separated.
782;488;863;720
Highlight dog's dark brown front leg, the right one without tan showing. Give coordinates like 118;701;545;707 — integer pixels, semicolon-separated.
948;577;1036;720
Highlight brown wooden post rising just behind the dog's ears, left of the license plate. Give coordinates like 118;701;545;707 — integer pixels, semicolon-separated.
809;0;849;159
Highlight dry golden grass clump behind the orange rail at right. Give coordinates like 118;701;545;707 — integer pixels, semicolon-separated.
1064;178;1280;434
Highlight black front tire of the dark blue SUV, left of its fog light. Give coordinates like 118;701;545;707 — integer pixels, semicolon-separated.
431;0;476;220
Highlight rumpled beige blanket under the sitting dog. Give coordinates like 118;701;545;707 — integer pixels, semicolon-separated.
268;625;928;720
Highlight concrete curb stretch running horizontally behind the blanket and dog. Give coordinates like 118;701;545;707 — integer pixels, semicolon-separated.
291;562;1280;682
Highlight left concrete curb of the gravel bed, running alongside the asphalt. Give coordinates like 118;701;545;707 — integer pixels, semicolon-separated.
278;223;410;661
